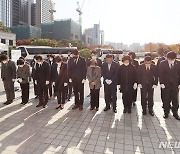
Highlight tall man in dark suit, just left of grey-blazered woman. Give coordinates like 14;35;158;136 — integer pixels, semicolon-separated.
69;50;87;110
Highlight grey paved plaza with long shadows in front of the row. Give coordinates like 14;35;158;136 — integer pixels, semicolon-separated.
0;79;180;154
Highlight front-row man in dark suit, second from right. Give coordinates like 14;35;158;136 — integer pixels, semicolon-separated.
138;56;158;116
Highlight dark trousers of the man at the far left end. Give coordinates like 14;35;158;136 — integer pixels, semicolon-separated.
3;79;15;101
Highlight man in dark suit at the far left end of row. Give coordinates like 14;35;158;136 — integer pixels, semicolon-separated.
0;55;16;105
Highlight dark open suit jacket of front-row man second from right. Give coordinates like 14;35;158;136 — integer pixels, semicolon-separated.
138;64;158;87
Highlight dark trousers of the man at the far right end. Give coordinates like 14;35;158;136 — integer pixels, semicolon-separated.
162;86;179;114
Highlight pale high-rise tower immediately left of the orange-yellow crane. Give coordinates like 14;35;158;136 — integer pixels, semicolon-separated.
35;0;53;27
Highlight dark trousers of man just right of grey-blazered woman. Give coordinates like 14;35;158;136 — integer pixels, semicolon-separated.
104;83;117;109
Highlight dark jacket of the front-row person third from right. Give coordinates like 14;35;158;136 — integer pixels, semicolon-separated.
119;64;137;93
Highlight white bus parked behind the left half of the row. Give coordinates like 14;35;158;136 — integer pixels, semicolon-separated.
17;46;77;61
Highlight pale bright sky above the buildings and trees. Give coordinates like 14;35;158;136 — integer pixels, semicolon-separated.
54;0;180;44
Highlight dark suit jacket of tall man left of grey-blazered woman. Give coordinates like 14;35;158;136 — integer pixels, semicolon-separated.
68;56;87;82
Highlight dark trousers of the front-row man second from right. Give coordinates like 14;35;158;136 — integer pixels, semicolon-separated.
141;84;154;111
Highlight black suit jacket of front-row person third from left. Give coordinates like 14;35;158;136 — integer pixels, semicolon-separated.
34;61;51;84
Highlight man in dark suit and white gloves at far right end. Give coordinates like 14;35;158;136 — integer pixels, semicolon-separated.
159;51;180;120
